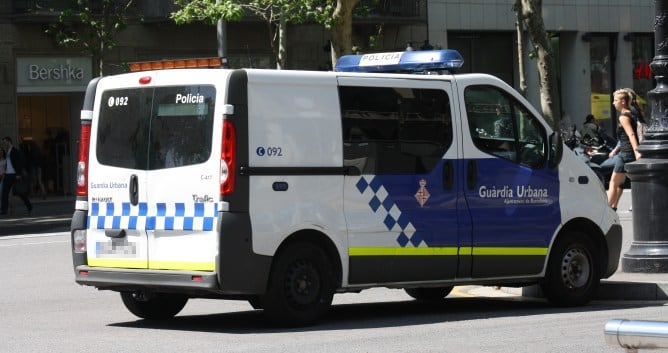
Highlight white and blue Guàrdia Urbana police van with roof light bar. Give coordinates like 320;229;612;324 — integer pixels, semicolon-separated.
71;50;622;325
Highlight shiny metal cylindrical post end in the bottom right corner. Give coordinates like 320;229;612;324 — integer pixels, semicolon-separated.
604;319;668;352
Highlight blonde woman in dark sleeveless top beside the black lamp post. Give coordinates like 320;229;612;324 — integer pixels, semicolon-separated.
608;89;641;210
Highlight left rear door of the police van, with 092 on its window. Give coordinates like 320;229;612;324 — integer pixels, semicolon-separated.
87;75;152;268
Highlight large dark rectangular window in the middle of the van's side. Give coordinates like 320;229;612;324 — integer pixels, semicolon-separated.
339;86;453;174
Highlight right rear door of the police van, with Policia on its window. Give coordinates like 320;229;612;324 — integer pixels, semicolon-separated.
146;81;222;271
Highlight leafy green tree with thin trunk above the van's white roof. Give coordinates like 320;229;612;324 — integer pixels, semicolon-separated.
171;0;313;70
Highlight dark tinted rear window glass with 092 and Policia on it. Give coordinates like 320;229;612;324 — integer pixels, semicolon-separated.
96;85;215;170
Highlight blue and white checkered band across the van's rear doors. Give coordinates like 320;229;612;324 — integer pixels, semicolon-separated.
88;202;218;230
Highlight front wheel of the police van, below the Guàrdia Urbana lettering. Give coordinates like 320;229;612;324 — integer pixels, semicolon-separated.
540;232;601;306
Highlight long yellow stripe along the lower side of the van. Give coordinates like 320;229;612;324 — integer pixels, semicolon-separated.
348;246;547;256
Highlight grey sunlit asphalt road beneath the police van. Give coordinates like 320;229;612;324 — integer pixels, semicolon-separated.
0;233;668;353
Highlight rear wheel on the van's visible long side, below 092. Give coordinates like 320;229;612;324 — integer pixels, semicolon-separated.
261;243;335;326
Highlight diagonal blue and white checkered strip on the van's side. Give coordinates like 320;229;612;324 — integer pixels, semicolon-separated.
356;176;426;247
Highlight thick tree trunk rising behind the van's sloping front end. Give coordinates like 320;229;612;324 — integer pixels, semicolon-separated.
513;0;561;130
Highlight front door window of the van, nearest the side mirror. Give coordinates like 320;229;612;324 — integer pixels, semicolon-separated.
464;86;547;169
